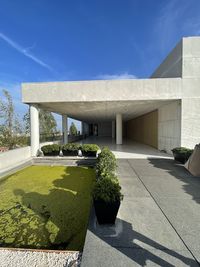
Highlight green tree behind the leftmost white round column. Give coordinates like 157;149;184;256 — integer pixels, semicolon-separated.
23;109;57;135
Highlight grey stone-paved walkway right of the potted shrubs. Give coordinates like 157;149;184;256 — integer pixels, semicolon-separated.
81;159;200;267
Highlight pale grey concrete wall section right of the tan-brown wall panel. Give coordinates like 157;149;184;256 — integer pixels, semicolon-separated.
158;100;181;153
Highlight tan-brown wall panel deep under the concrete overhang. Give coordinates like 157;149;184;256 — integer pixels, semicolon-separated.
126;110;158;148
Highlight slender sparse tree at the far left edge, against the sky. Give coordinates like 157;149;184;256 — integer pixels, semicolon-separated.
0;90;22;149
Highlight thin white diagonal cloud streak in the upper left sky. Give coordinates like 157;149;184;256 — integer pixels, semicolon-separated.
0;32;52;71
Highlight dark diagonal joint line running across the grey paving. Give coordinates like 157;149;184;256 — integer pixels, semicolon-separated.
127;159;200;266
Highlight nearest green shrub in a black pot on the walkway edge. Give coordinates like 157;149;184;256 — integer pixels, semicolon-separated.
93;177;123;224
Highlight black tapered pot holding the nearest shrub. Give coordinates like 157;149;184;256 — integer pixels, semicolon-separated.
94;200;120;224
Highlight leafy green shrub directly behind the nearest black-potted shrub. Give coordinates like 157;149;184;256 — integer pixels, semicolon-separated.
96;147;117;178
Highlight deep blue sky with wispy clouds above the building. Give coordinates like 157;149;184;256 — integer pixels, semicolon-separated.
0;0;200;130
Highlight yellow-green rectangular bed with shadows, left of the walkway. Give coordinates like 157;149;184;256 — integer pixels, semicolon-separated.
0;166;95;250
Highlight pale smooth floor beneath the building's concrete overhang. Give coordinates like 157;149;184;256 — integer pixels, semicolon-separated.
79;136;171;159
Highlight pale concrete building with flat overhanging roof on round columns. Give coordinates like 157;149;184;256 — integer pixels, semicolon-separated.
22;37;200;156
